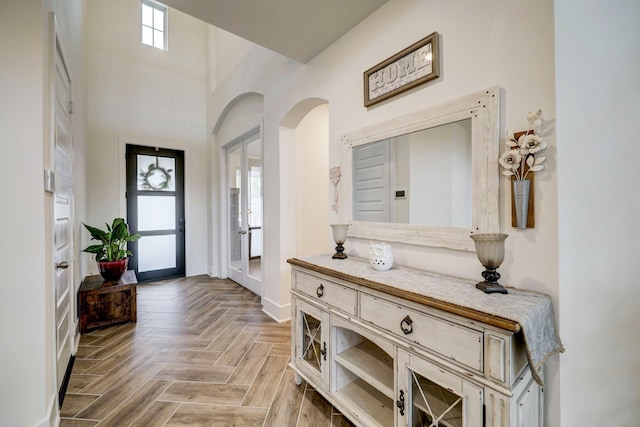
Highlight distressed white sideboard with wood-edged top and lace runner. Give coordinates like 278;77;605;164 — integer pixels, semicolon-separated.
288;255;556;427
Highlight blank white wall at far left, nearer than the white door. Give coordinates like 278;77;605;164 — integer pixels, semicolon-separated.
0;2;48;425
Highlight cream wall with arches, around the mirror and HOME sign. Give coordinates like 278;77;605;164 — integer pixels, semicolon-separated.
209;0;562;425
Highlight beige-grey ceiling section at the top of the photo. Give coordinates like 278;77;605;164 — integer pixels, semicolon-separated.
161;0;387;63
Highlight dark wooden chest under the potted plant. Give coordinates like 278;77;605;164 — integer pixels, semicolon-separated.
78;270;138;334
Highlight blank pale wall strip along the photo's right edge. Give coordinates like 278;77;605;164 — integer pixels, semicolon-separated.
555;0;640;426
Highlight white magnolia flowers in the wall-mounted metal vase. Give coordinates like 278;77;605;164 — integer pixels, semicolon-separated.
499;110;547;180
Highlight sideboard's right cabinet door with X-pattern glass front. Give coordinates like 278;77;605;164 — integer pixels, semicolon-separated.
398;350;484;427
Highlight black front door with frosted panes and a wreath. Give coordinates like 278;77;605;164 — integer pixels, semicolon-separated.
127;144;186;282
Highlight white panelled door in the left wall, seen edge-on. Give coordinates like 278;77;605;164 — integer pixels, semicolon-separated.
53;38;75;396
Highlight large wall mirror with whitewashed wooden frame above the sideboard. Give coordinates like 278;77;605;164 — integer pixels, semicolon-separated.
342;87;500;251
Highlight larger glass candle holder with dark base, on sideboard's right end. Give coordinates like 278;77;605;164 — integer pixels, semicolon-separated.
471;233;509;294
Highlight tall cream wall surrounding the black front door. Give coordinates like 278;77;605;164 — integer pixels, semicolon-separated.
83;0;208;275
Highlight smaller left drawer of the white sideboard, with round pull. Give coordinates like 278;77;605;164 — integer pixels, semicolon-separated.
294;272;358;314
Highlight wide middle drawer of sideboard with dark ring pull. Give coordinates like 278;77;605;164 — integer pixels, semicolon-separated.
360;292;483;371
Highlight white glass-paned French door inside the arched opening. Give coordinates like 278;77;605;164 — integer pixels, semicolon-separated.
226;131;263;295
